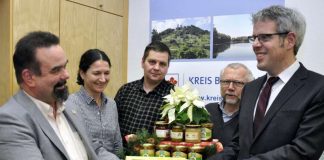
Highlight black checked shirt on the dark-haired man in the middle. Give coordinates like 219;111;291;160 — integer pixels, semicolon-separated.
115;78;173;136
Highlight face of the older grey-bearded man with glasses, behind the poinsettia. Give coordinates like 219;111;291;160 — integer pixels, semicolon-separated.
221;67;247;105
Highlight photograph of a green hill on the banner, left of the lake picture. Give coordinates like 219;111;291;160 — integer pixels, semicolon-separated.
152;17;211;60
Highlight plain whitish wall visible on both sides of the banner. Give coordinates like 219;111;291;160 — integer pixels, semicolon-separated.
127;0;324;81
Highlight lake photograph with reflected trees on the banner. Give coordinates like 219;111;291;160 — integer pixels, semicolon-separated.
213;14;255;61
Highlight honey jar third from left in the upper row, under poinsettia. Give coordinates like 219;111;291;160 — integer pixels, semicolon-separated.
185;124;201;143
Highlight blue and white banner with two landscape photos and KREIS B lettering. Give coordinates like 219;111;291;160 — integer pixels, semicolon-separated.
150;0;284;103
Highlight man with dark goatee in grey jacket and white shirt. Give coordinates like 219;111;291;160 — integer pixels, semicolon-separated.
0;31;97;160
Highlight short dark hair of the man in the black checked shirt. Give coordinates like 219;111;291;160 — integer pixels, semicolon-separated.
142;41;171;64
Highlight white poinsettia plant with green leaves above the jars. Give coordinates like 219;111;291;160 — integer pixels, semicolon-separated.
161;83;210;125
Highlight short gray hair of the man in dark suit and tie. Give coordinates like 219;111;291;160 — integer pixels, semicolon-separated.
252;5;306;55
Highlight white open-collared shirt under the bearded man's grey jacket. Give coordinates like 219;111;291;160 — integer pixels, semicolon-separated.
25;92;88;160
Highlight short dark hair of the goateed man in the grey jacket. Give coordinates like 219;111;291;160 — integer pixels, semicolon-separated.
13;31;60;84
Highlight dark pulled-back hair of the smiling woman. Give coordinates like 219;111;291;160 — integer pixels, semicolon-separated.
77;49;111;85
